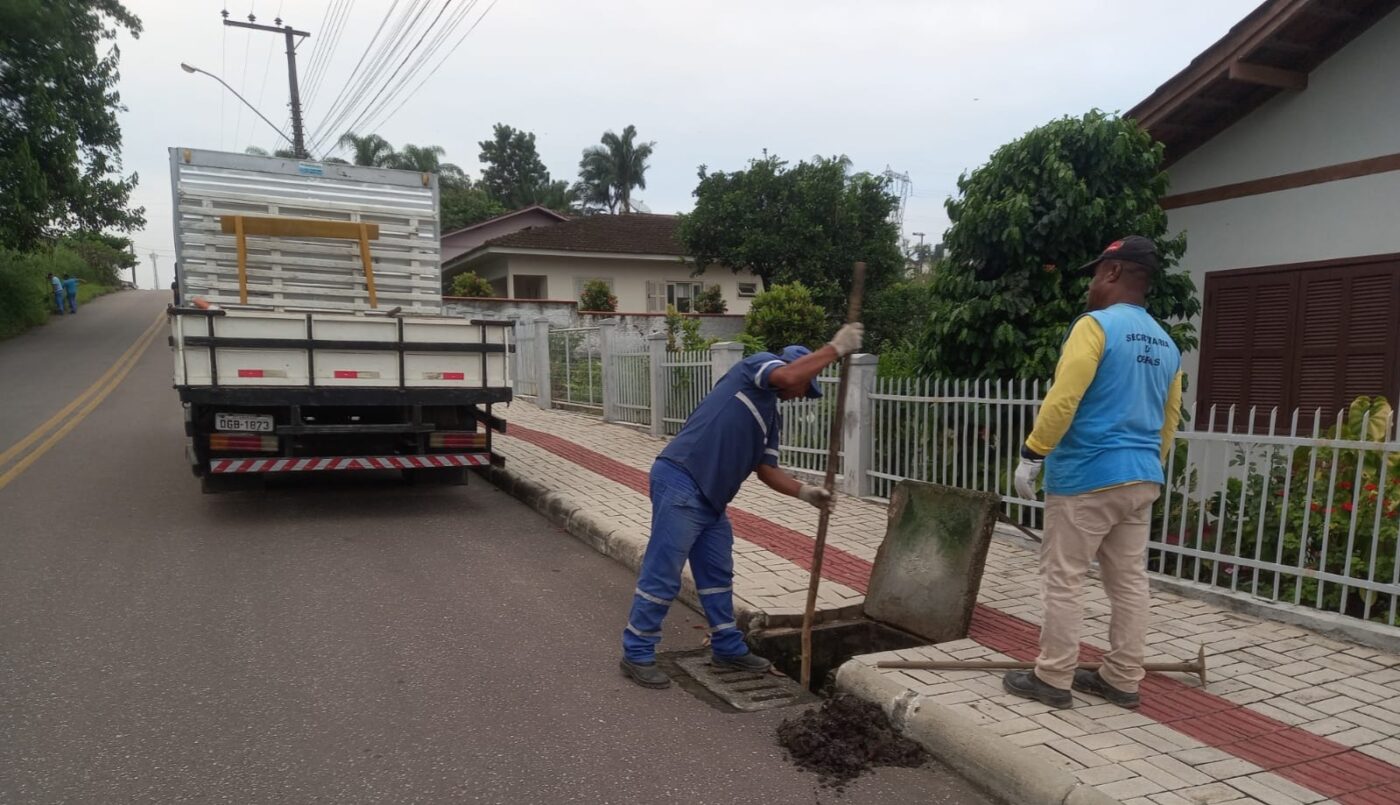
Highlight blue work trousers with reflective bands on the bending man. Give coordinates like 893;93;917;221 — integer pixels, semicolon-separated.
622;459;749;664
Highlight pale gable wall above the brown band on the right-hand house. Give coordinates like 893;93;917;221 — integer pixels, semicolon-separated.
1169;11;1400;193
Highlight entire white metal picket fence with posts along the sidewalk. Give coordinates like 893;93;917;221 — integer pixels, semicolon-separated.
515;328;1400;626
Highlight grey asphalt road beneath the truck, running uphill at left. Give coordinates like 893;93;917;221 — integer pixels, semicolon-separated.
0;293;987;804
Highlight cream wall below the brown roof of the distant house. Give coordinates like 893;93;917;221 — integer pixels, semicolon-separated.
472;253;763;315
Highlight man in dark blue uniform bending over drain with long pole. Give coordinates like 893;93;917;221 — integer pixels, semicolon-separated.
622;323;864;687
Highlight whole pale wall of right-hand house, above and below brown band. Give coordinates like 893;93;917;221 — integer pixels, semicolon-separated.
1168;13;1400;402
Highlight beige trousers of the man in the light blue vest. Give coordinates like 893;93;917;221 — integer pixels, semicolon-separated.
1036;483;1162;693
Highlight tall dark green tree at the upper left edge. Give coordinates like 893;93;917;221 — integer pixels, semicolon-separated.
0;0;146;249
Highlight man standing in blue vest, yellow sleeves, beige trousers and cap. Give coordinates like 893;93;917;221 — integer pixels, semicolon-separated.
1002;235;1182;708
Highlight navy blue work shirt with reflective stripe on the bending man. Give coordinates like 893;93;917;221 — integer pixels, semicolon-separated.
658;353;787;511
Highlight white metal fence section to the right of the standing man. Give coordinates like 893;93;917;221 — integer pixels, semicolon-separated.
1148;405;1400;626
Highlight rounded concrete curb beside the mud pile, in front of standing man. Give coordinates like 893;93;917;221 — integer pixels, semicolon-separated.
836;659;1119;805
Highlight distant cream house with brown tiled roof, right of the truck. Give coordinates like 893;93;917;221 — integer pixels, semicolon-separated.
444;213;763;314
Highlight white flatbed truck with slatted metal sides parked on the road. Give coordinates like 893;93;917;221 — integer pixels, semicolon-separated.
168;147;514;493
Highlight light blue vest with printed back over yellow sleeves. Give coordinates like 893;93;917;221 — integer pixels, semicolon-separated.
1046;304;1182;494
